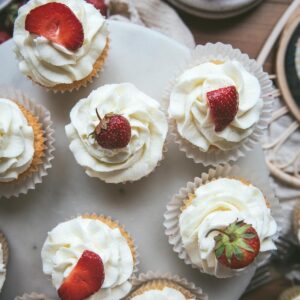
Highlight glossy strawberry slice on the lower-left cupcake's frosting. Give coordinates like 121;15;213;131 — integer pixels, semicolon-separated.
58;250;105;300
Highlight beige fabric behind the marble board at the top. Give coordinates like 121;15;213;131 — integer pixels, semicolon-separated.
107;0;195;48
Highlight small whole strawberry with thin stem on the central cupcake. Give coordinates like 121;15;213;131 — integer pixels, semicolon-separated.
91;110;131;149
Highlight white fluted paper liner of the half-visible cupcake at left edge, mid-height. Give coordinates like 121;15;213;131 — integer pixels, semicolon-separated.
0;87;55;199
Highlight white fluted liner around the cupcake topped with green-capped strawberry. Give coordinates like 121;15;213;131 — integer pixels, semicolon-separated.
164;164;283;278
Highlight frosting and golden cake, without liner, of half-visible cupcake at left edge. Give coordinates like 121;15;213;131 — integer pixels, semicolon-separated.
0;98;45;183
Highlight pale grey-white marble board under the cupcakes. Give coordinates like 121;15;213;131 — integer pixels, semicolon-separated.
0;21;268;300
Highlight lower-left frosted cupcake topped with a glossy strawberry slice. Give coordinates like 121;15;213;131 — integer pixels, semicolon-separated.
41;215;137;300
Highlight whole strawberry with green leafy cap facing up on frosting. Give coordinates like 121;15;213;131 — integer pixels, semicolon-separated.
210;221;260;269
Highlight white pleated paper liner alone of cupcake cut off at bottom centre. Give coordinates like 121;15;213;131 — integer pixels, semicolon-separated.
129;271;208;300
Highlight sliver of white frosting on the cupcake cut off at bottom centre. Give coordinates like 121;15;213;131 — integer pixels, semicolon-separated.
132;287;192;300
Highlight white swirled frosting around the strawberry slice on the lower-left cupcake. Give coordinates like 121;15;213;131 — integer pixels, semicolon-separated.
42;217;134;300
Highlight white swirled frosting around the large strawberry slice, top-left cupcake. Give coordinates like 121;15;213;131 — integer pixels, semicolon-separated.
13;0;108;87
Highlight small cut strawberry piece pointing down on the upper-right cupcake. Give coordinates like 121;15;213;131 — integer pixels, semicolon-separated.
207;86;239;132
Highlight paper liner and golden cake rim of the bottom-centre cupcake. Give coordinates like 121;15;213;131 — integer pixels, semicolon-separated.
126;271;208;300
